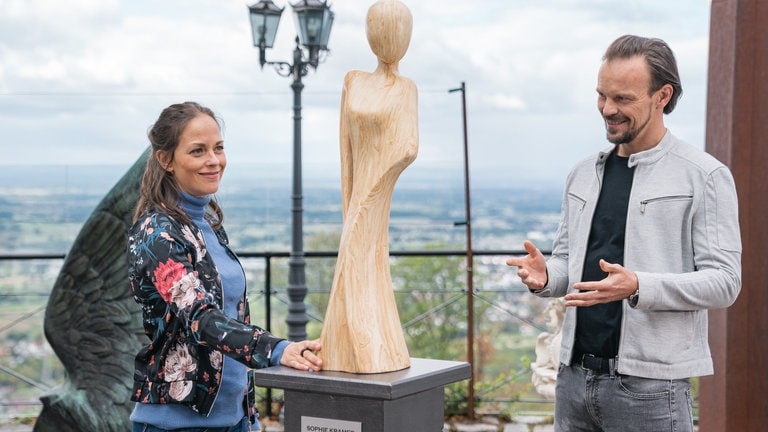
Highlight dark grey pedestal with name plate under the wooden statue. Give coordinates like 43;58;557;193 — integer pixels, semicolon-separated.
256;358;471;432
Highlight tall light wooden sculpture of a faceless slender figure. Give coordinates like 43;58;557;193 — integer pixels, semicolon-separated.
320;0;419;373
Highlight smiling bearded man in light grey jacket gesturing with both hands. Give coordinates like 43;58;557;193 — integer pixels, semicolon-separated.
507;35;741;432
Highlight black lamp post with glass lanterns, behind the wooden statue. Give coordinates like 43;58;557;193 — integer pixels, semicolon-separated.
248;0;333;341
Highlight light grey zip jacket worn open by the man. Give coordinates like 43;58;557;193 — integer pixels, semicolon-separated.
534;131;741;379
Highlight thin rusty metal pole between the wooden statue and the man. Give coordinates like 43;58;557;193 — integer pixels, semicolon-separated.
449;81;475;420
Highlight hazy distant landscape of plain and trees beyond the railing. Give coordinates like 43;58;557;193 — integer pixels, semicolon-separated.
0;166;561;415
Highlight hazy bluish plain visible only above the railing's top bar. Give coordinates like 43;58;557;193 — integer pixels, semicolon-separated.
0;165;561;253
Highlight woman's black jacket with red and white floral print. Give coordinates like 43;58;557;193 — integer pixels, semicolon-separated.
128;211;282;415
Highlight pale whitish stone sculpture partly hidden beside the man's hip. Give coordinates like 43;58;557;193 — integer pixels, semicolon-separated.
531;298;565;400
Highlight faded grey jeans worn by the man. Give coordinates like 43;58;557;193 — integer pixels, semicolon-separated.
555;362;693;432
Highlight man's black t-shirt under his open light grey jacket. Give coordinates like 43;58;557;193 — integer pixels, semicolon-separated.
574;151;634;357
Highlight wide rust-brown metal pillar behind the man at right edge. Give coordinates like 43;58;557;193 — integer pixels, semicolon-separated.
699;0;768;432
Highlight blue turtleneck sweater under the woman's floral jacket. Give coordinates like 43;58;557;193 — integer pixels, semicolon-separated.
131;192;249;429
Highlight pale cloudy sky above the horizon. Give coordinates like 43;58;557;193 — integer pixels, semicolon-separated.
0;0;710;185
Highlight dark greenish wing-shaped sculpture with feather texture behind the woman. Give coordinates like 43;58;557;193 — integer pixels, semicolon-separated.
34;152;148;432
